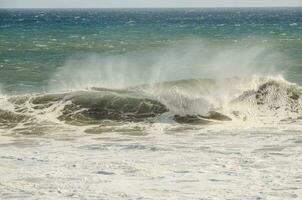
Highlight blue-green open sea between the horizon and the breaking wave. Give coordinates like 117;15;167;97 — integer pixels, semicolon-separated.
0;8;302;93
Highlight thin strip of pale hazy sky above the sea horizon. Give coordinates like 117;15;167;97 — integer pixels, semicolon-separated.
0;0;302;8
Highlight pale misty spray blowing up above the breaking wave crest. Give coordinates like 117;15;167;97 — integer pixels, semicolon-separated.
48;40;282;91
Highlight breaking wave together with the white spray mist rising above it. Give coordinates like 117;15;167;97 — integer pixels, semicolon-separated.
0;40;302;134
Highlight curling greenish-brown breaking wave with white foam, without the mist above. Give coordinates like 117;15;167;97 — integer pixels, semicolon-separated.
0;77;302;132
